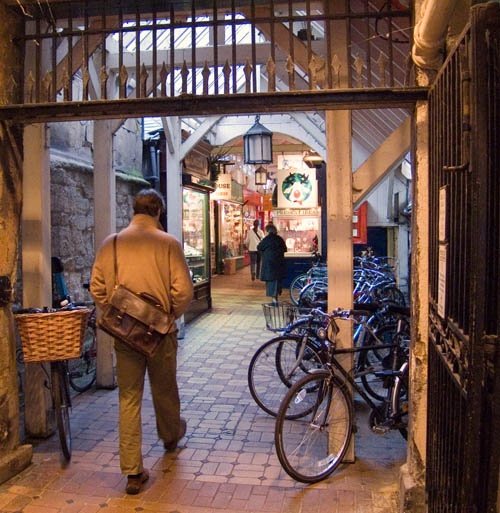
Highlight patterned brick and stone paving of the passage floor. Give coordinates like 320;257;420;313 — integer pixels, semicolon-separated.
0;269;406;513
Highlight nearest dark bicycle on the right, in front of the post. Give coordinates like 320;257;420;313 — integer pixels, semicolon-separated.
275;310;408;483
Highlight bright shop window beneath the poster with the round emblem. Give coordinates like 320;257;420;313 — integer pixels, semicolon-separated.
273;215;321;256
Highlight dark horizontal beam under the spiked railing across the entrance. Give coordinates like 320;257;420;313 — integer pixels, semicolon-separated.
0;87;427;123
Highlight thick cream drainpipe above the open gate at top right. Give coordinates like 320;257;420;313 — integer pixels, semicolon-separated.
412;0;457;70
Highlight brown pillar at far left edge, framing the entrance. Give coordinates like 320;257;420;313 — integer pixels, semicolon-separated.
0;4;32;483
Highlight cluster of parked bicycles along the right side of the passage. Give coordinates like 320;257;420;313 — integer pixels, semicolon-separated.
248;257;410;483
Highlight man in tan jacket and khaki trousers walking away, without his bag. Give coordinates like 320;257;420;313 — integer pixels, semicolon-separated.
90;189;193;495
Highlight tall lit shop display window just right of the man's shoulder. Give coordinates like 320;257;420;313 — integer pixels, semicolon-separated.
182;188;209;284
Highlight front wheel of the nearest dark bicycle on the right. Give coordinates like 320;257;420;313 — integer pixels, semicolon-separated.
274;371;353;483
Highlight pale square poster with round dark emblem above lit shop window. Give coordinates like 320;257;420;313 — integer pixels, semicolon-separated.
277;169;318;208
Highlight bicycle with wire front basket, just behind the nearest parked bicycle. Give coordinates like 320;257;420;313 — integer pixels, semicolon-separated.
247;303;409;417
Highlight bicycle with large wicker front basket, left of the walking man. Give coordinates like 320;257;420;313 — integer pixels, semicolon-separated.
14;307;89;461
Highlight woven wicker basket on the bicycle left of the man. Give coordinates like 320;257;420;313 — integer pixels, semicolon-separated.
15;308;90;362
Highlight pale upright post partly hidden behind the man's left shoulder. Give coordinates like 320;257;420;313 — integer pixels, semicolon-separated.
93;121;116;388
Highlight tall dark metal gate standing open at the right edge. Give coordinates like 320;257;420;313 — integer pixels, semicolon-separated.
426;3;500;513
